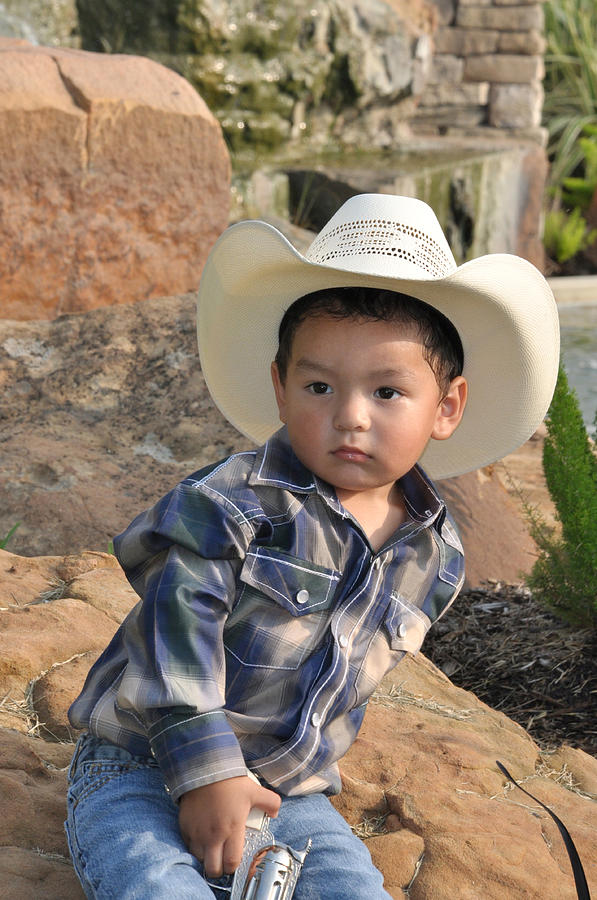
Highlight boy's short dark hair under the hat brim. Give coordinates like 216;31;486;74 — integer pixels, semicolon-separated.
276;287;464;393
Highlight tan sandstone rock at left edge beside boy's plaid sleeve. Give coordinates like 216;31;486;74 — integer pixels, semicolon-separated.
0;550;138;741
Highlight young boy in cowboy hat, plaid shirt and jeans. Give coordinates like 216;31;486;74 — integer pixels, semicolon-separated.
67;195;558;900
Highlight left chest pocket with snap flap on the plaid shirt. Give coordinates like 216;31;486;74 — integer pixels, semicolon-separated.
224;547;340;670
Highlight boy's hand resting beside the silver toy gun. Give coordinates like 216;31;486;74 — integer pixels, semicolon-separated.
178;776;280;878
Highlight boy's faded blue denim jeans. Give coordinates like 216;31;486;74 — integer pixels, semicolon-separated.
66;734;391;900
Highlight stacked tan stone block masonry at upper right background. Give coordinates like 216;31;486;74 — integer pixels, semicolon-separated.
412;0;545;143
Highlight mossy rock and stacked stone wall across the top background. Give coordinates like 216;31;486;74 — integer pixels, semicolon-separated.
0;0;545;147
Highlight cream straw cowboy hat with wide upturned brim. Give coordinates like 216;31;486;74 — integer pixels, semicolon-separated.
198;194;559;478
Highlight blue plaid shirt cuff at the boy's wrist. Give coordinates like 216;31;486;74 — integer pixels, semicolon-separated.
148;709;247;800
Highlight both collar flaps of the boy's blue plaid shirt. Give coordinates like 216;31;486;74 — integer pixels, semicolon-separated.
249;426;445;524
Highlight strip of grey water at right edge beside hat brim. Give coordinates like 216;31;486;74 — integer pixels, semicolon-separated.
559;297;597;436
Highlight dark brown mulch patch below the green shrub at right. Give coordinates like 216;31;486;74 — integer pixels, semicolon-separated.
423;584;597;756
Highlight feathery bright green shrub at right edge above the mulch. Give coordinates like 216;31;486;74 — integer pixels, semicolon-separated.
527;367;597;629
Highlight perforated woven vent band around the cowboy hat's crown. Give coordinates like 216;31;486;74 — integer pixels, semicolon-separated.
308;219;454;278
